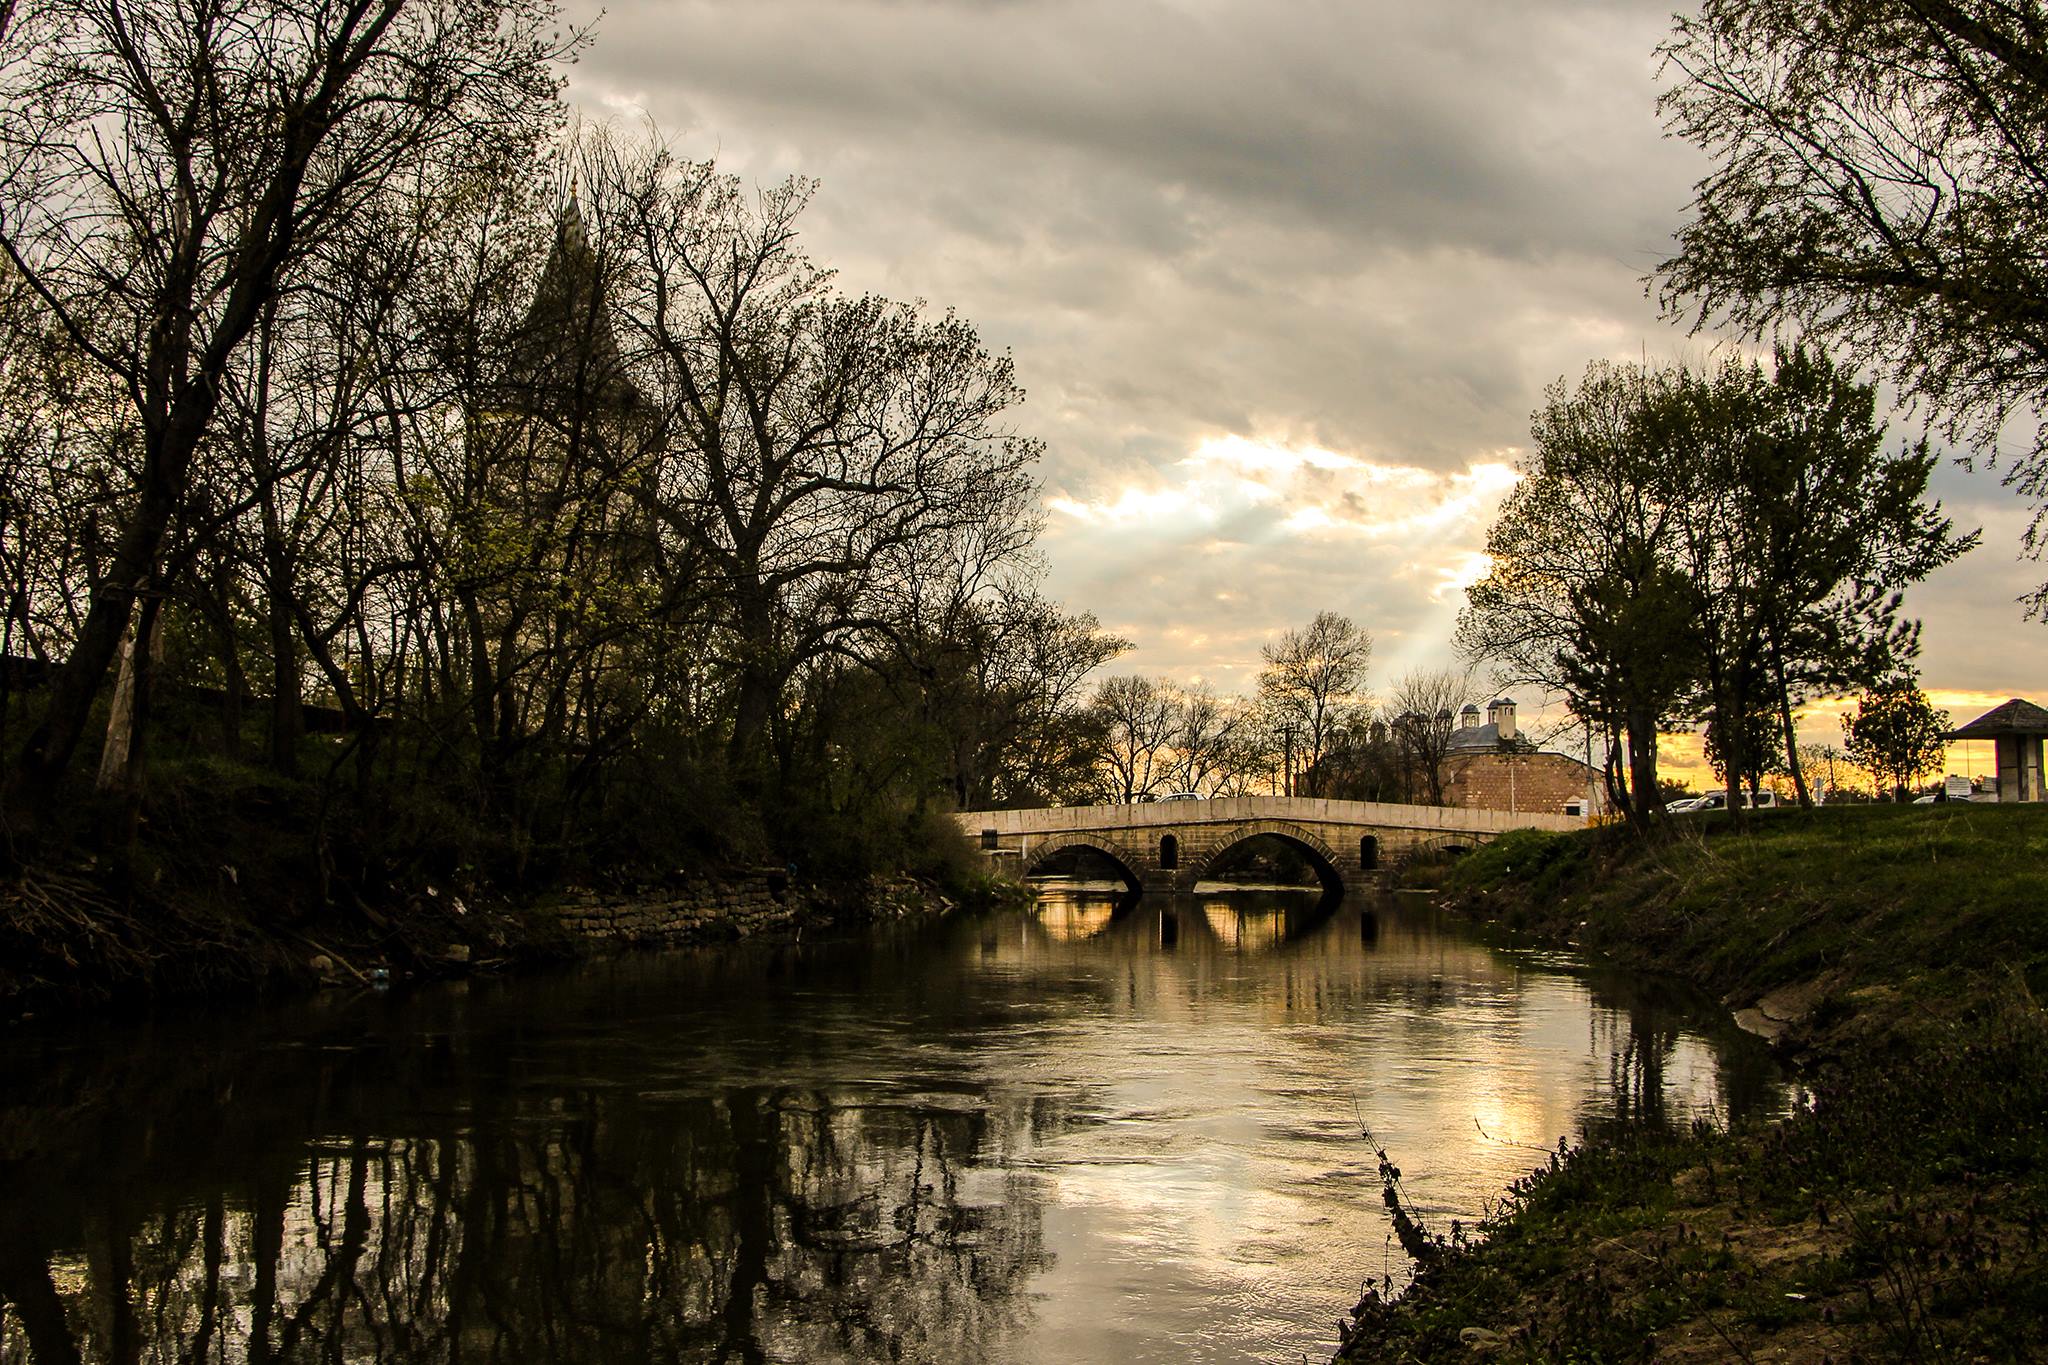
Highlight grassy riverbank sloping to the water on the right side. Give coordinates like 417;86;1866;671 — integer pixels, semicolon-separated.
1339;804;2048;1361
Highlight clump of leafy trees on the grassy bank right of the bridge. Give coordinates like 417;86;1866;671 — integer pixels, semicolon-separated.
1460;348;1974;821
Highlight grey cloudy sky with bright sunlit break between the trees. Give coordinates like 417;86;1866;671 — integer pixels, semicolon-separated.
571;0;2048;757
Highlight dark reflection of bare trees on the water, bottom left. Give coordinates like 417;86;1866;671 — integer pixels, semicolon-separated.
0;1089;1049;1365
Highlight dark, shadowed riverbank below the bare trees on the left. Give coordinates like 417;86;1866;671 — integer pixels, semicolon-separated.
0;777;995;1023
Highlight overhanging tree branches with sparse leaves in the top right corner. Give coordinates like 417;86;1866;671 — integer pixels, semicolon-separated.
1657;0;2048;614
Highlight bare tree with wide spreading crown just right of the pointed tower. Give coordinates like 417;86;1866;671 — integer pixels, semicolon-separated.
586;139;1038;794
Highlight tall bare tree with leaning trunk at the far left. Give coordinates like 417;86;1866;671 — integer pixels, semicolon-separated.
0;0;575;790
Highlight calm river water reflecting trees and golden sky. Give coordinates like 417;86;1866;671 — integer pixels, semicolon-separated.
0;888;1780;1365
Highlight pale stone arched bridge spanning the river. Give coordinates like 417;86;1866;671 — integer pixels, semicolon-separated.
954;796;1585;890
